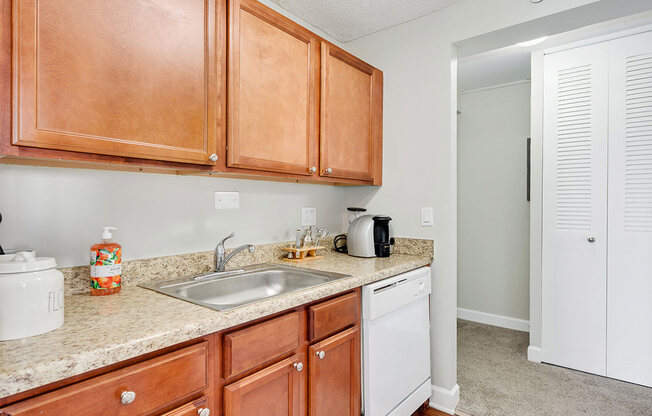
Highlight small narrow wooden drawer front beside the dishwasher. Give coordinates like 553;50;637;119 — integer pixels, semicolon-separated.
308;293;360;341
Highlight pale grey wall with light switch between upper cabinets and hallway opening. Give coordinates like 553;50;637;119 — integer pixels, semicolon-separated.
344;0;593;411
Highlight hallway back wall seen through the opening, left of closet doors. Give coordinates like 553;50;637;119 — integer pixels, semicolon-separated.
457;82;530;320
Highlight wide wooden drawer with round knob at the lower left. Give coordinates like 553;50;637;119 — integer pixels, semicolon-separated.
4;342;208;416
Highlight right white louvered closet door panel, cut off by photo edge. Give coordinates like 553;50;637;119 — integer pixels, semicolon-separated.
607;33;652;386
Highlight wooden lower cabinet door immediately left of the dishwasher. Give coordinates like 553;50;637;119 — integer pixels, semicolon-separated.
308;327;360;416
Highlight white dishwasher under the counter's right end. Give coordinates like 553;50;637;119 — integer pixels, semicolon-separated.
362;267;431;416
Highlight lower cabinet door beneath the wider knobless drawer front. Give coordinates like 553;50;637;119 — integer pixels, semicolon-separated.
224;356;304;416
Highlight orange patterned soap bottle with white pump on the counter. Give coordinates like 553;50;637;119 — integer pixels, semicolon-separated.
90;227;122;296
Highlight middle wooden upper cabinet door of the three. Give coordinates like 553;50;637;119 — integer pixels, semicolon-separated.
227;0;319;175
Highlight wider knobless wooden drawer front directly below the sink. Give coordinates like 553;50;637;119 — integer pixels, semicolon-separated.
224;312;299;379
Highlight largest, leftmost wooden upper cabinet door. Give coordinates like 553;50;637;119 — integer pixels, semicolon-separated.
12;0;225;164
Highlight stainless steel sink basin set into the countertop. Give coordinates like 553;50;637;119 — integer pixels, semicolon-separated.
141;264;350;311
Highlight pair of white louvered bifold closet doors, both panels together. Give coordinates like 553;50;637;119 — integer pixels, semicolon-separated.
542;28;652;386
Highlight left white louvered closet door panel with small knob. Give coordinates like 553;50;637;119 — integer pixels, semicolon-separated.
541;44;609;375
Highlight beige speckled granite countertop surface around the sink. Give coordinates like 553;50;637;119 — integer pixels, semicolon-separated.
0;252;432;397
